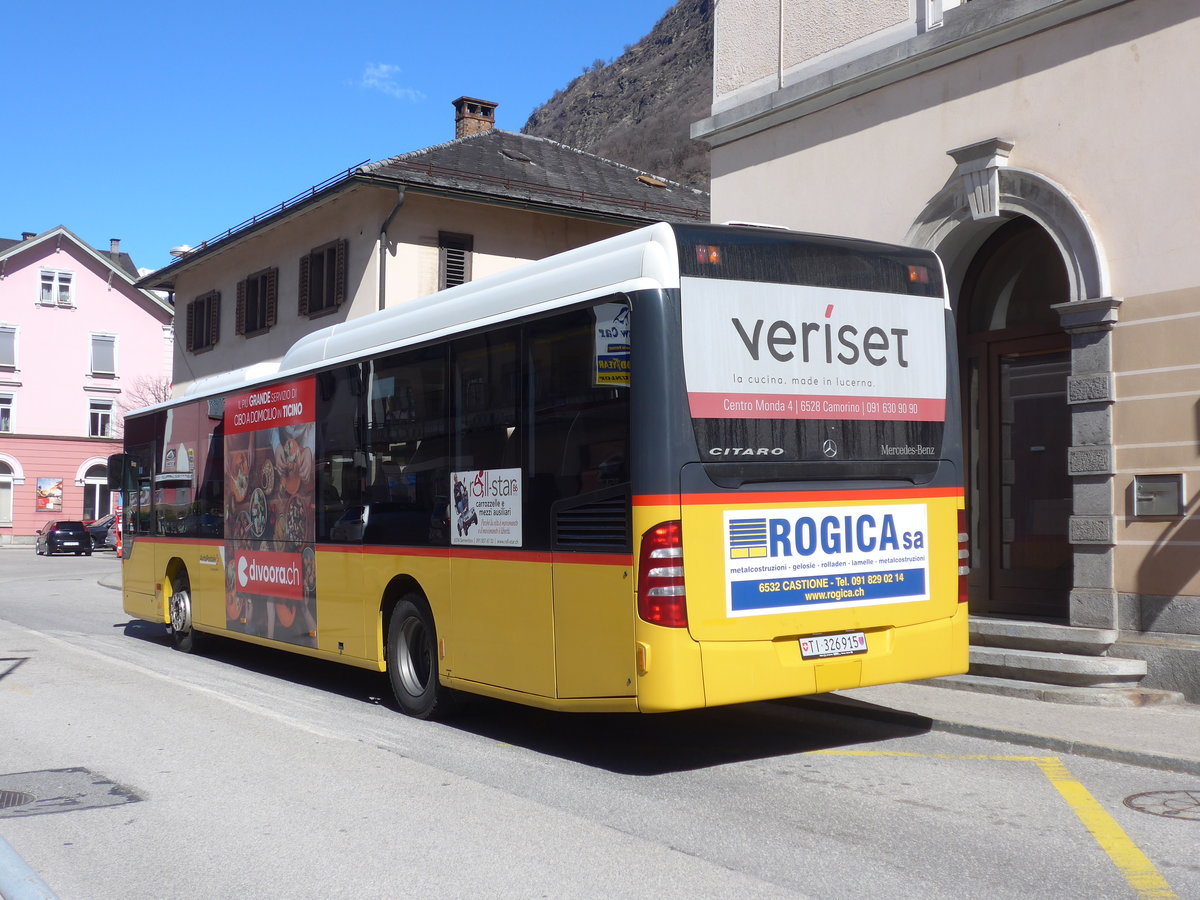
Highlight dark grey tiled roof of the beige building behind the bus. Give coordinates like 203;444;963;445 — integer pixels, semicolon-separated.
358;128;709;222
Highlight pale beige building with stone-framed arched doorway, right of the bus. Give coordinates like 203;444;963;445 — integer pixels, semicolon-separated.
692;0;1200;702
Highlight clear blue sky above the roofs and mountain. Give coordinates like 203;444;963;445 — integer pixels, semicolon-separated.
0;0;673;269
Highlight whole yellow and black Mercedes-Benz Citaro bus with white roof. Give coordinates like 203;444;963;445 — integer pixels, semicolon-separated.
109;223;967;718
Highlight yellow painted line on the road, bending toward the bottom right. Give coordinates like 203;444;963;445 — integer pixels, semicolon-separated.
812;750;1176;900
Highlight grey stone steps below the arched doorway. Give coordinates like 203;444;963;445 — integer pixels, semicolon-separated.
934;616;1184;707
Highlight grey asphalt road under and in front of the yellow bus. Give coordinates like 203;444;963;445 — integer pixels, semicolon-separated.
0;550;1200;899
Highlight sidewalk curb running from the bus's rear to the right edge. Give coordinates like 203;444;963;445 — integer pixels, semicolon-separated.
820;697;1200;775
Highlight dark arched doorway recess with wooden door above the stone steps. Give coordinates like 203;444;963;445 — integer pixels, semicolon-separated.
959;216;1072;620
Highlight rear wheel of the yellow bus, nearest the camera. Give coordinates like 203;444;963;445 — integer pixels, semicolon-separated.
388;594;455;719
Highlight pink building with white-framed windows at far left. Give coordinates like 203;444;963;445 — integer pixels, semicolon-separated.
0;226;174;544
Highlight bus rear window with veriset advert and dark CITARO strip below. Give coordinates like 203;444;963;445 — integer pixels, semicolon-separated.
680;277;948;462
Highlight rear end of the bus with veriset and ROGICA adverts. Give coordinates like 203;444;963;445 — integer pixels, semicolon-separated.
631;227;967;712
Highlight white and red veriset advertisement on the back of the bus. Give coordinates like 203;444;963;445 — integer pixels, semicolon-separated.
682;278;946;421
